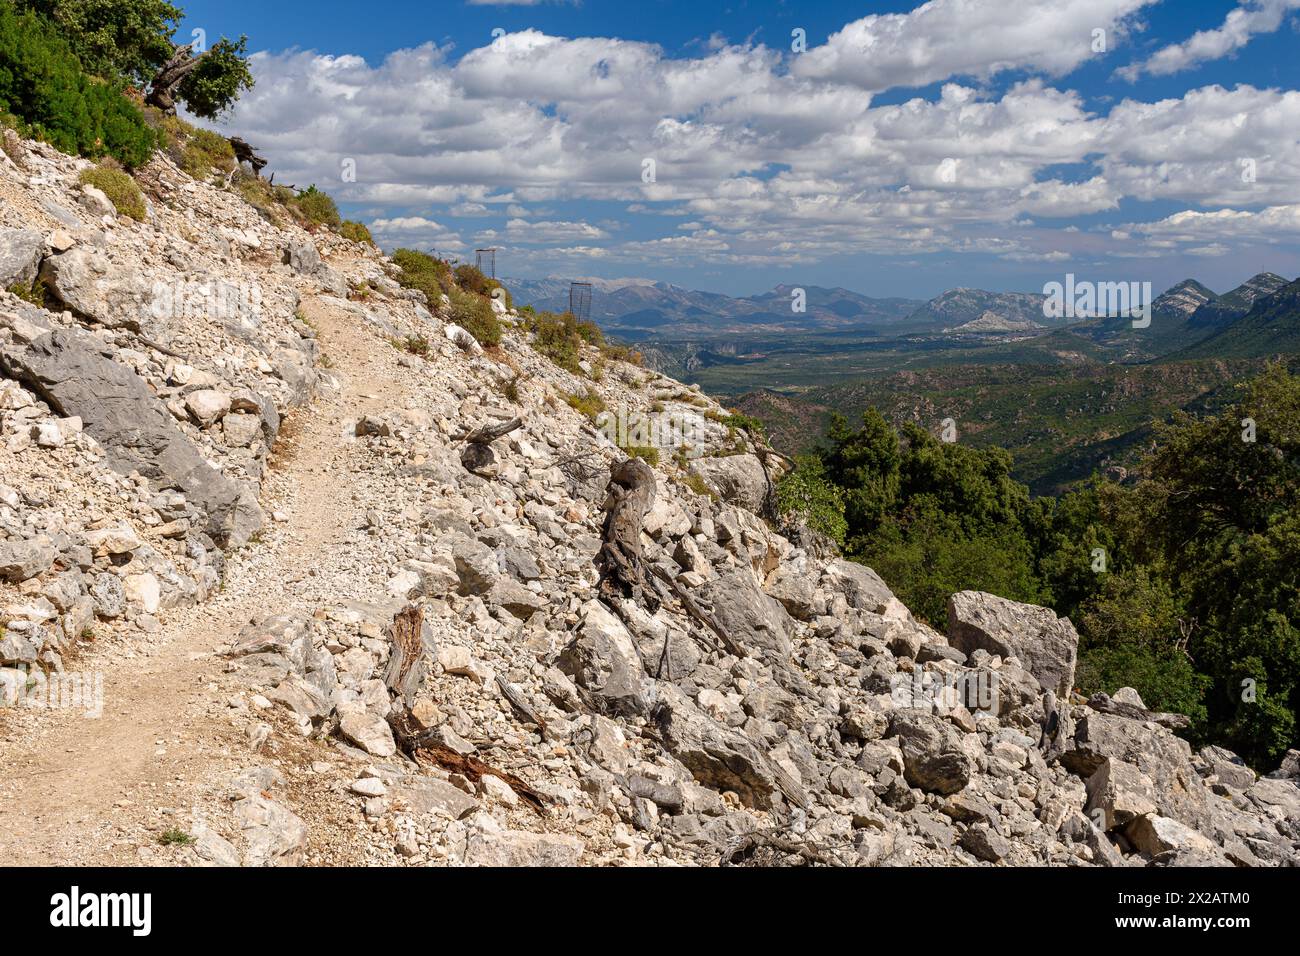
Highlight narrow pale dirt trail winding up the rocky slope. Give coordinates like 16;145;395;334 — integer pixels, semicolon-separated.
0;299;402;865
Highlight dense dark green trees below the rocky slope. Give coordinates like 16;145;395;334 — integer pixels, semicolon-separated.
780;364;1300;766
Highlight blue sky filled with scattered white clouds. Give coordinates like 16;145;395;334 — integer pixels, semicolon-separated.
181;0;1300;298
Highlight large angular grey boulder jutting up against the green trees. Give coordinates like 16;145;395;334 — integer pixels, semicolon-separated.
948;591;1079;698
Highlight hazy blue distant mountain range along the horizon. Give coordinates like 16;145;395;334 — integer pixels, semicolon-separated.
504;272;1300;372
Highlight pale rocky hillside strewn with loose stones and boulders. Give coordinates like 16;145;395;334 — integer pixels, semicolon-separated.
0;130;1300;866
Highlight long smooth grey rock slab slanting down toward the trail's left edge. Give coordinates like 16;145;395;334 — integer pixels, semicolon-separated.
0;329;265;545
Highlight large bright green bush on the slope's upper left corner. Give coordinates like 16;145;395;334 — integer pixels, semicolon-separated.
0;3;157;168
